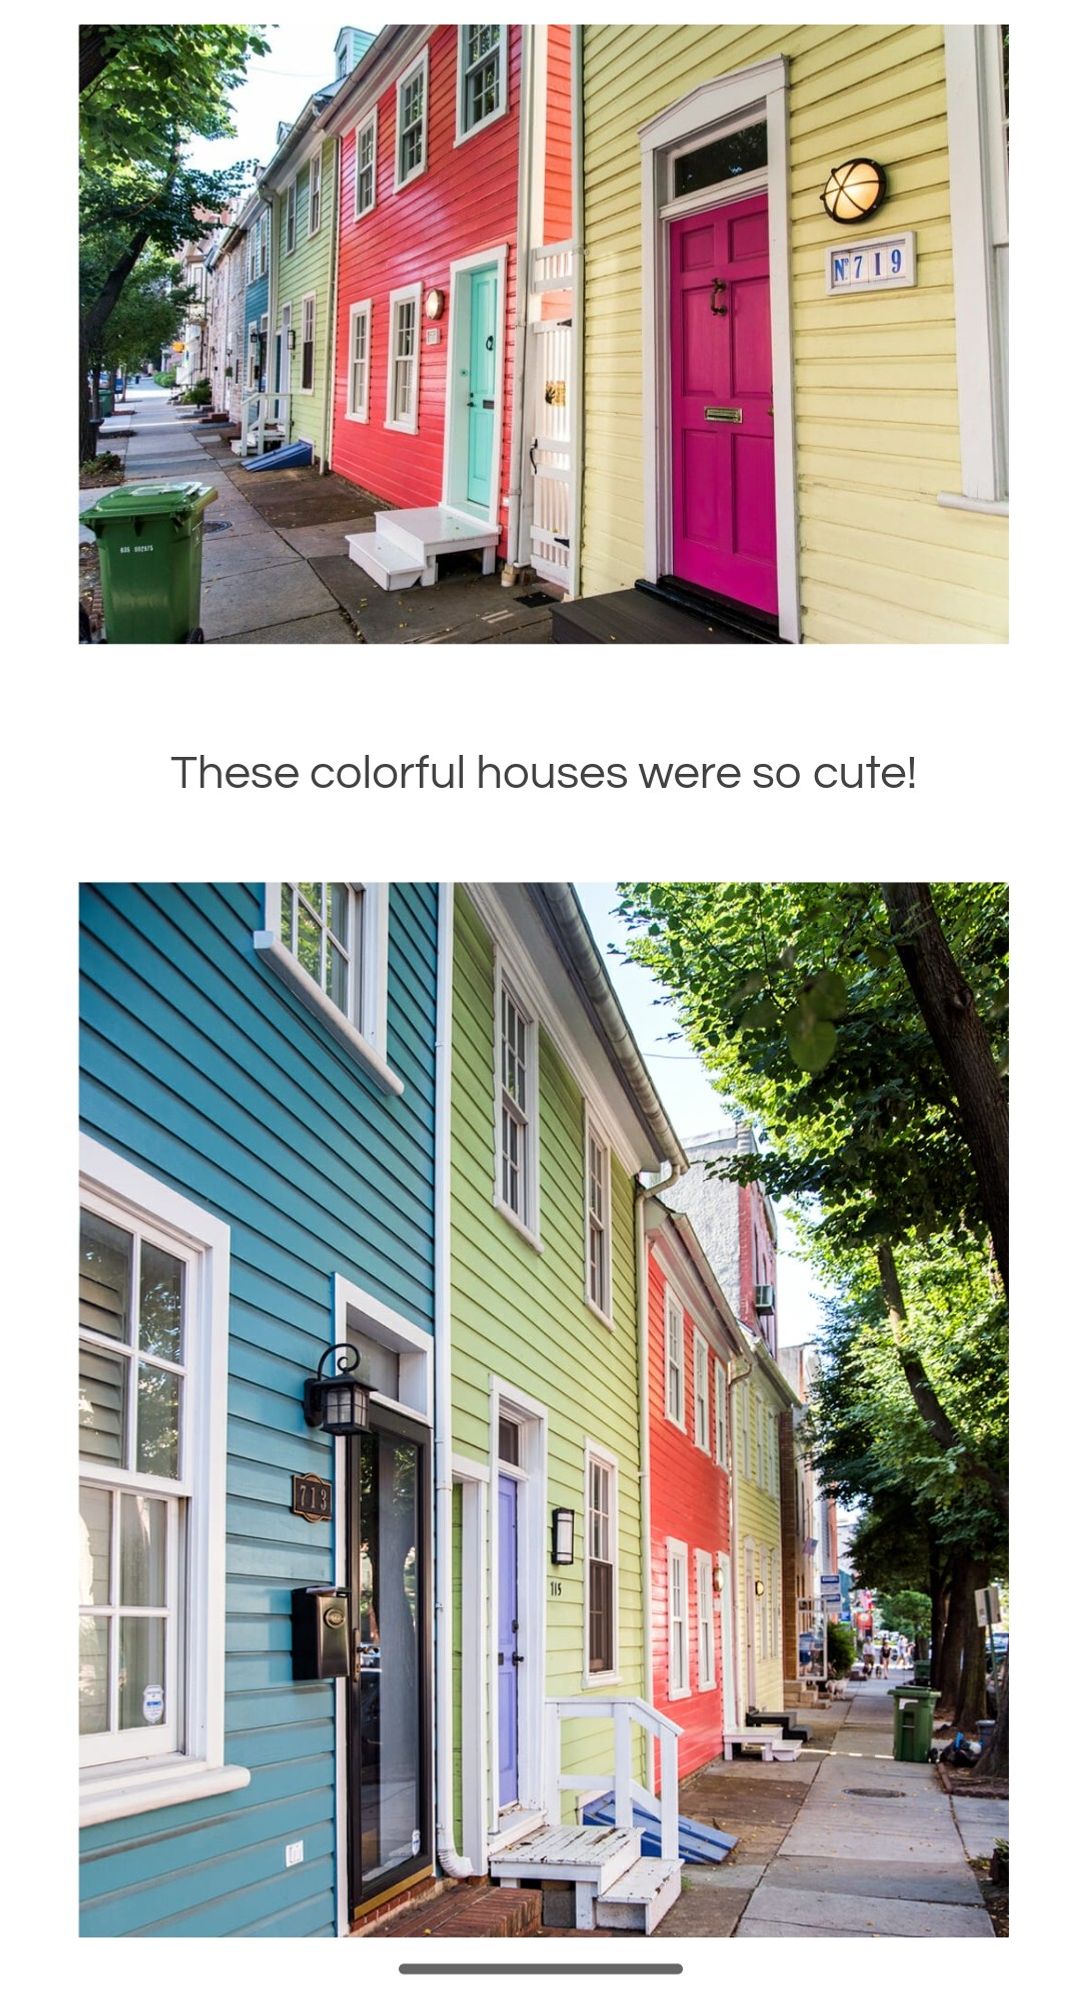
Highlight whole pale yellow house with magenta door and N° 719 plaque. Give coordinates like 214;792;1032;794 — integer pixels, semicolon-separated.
575;24;1009;642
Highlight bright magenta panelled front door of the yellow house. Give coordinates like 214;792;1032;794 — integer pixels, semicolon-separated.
671;194;777;612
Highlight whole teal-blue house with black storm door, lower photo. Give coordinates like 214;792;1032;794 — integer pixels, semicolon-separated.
80;882;448;1936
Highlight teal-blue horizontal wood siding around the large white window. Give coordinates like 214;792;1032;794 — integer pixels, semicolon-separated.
82;884;436;1936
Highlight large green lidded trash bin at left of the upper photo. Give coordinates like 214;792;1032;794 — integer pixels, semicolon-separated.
80;480;218;646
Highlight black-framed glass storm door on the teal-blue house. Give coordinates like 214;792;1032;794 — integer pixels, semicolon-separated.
348;1412;432;1916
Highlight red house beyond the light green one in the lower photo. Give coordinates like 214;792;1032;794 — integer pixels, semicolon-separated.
647;1200;745;1778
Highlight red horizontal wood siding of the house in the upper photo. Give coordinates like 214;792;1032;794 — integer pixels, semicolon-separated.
332;26;522;552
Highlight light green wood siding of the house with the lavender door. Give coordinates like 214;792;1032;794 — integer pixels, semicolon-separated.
450;894;645;1812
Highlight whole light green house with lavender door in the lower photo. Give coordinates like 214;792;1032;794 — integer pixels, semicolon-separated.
436;884;685;1892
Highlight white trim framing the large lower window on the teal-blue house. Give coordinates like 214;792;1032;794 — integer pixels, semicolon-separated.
80;1138;250;1826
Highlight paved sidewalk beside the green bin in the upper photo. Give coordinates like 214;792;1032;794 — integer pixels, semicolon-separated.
80;388;551;646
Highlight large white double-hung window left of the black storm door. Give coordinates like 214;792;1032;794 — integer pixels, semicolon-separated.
78;1140;248;1824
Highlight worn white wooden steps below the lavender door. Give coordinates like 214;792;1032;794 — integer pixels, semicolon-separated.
488;1826;681;1936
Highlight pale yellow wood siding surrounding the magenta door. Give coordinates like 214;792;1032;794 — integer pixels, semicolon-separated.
583;24;1007;642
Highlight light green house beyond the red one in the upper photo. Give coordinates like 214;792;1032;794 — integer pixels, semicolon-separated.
260;28;374;466
